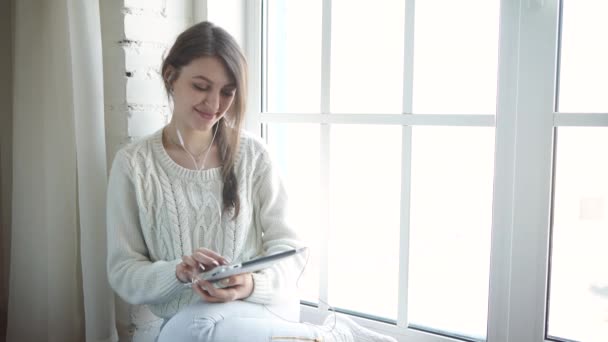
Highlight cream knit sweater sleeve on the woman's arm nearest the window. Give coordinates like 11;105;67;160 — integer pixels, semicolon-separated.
245;151;305;304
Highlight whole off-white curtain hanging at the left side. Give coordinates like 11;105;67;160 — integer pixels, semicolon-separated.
7;0;117;342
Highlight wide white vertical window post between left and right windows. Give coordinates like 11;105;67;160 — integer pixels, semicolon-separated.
488;0;559;342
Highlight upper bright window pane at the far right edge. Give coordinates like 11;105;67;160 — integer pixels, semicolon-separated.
559;0;608;113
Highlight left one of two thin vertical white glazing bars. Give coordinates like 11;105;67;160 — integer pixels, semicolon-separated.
319;0;331;311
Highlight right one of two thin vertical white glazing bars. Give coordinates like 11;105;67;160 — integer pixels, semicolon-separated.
397;0;415;328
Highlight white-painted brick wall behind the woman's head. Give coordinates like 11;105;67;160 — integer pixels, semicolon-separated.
99;0;194;170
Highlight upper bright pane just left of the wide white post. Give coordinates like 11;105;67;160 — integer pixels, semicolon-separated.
413;0;500;114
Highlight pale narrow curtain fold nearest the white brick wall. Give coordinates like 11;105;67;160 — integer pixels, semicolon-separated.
68;0;117;341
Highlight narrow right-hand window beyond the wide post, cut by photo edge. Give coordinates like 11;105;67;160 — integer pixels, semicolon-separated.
547;0;608;341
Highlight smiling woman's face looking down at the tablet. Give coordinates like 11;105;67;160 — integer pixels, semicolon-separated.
172;57;236;131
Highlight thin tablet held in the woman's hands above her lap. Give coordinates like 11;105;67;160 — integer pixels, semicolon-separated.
198;247;306;282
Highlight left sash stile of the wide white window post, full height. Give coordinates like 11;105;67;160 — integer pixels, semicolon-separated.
487;0;521;341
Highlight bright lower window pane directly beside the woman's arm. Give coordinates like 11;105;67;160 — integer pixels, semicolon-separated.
268;124;322;303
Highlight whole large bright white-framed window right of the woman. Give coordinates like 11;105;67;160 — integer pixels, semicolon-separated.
242;0;608;342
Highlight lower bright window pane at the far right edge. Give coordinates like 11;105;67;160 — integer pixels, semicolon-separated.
548;127;608;341
